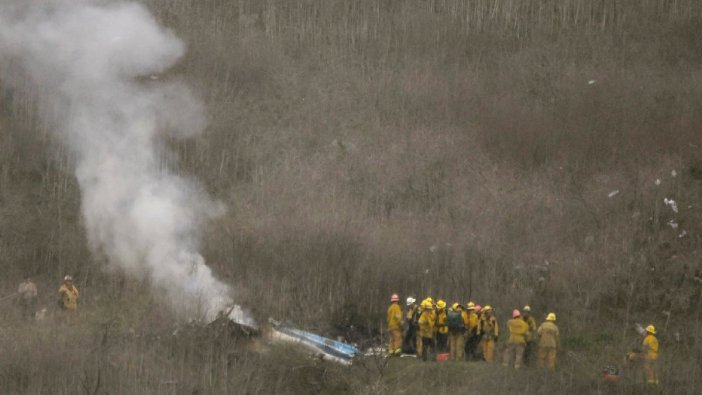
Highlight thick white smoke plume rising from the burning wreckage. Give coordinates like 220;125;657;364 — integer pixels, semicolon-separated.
0;0;250;323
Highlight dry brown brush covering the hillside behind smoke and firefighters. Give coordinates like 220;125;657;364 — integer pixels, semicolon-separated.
0;0;702;393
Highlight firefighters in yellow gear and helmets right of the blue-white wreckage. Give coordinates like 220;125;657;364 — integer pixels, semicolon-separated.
387;294;658;384
